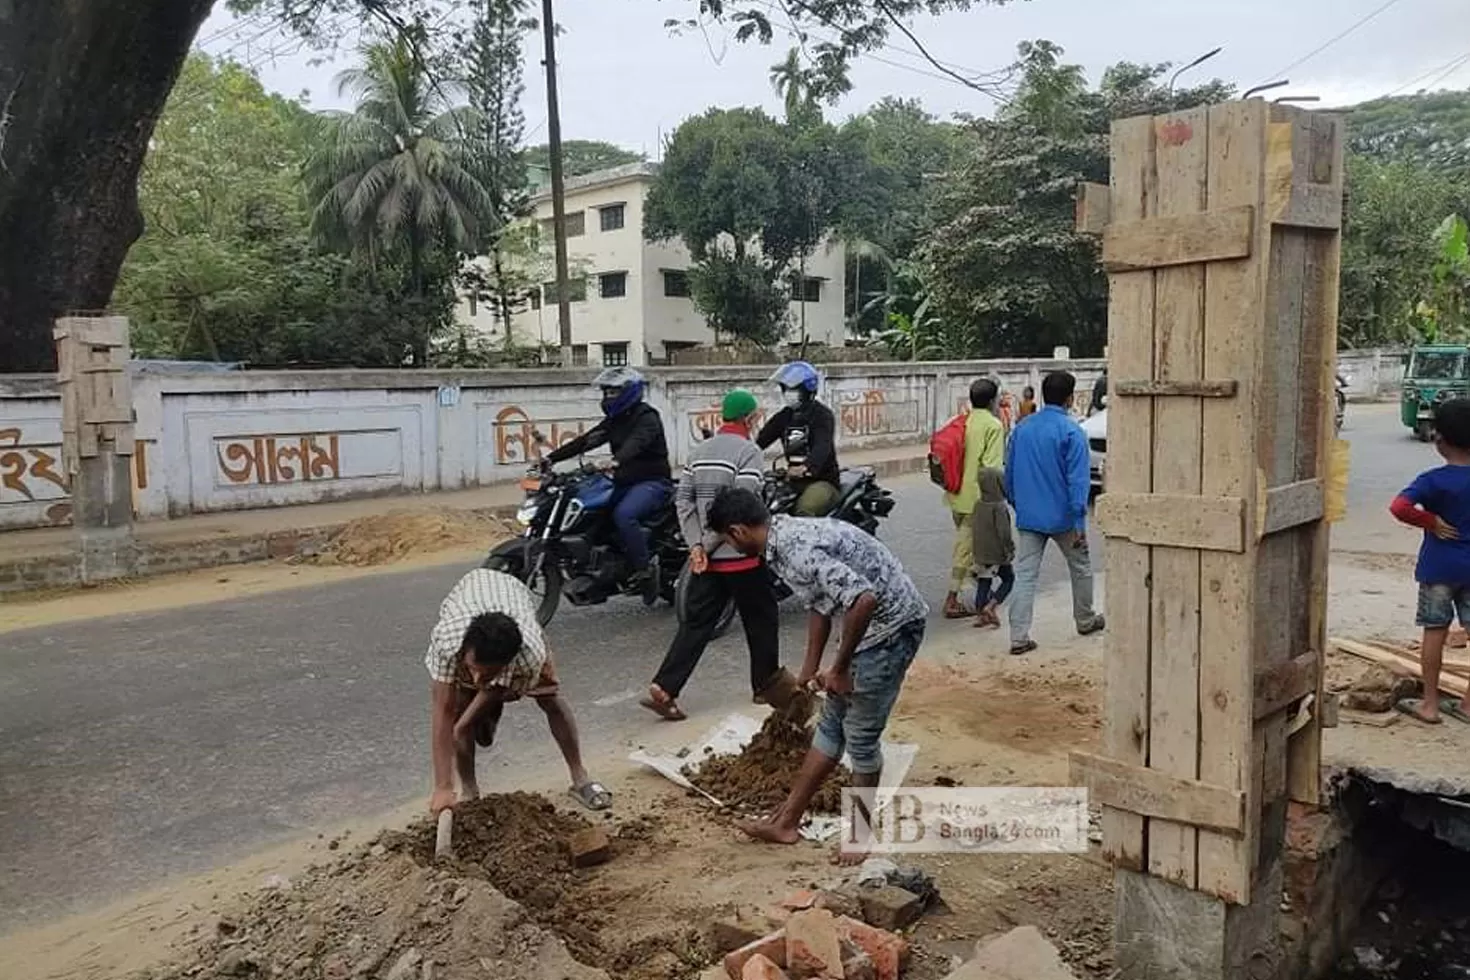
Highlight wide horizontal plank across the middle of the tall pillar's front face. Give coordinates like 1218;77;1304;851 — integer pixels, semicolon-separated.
1097;490;1245;554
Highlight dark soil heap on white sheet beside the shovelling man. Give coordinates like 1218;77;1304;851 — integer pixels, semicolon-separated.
684;711;851;814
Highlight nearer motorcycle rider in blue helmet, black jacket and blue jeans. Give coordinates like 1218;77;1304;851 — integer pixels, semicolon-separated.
545;367;673;605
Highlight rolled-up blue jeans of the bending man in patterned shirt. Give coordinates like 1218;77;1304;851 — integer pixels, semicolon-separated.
811;620;925;776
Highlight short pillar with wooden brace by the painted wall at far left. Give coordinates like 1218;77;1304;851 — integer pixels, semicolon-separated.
53;316;137;583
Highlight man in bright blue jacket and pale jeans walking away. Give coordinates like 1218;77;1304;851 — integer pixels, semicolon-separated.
1005;370;1105;654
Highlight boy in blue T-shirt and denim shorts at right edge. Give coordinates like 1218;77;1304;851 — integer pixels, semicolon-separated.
1389;398;1470;724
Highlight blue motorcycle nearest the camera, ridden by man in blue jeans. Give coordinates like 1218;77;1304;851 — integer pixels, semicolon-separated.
482;433;689;626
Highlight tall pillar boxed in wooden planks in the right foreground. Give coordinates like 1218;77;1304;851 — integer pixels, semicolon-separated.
1073;100;1342;980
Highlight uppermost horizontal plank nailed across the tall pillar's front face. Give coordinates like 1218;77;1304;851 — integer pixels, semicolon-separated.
1103;206;1255;272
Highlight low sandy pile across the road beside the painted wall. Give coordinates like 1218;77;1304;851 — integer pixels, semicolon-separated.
312;510;510;566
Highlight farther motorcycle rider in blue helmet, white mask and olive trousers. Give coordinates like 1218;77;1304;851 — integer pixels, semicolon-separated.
756;360;841;517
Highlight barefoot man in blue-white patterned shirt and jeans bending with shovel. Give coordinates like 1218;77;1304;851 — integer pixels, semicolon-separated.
706;489;929;862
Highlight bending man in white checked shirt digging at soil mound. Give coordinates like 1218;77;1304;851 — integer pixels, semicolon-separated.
423;569;613;814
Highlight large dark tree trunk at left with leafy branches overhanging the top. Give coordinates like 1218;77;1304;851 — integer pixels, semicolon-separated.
0;0;993;370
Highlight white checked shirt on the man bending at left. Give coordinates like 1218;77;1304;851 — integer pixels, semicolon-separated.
423;569;547;695
